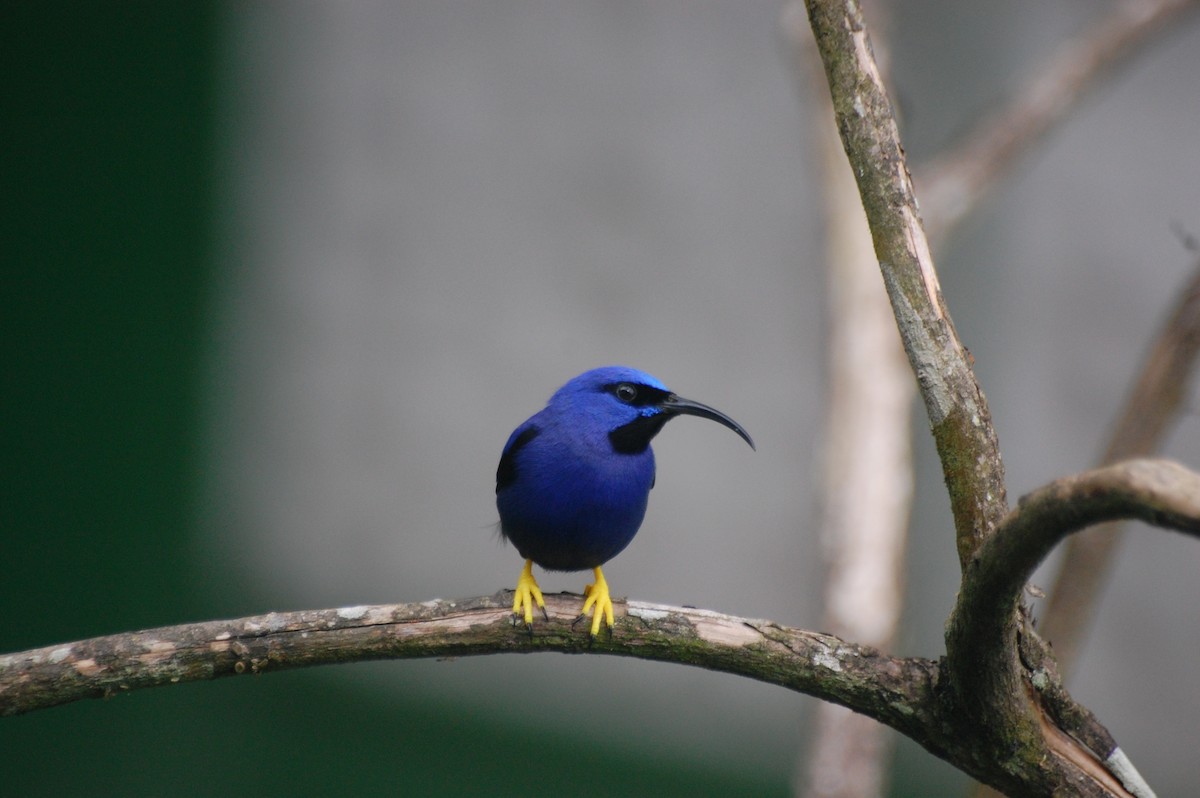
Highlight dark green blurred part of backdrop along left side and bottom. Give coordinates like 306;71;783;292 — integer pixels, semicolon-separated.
0;2;786;796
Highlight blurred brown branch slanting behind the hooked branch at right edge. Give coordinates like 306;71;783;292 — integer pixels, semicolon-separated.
1040;264;1200;674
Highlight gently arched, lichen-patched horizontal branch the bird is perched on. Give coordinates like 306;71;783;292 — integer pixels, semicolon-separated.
0;592;935;734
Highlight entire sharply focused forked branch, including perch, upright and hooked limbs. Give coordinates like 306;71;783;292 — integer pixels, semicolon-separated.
0;7;1200;796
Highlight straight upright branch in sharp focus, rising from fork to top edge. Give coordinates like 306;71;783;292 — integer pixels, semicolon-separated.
805;0;1007;566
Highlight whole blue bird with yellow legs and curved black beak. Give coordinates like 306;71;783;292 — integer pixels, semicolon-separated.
496;366;754;637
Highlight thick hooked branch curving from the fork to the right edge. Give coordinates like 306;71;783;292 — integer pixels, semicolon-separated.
942;460;1200;794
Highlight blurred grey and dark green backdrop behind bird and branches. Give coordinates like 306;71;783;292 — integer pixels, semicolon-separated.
0;0;1200;797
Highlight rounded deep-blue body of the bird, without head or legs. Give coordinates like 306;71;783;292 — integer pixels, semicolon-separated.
496;408;654;571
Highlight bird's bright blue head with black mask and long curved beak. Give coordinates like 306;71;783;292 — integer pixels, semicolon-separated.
547;366;754;454
